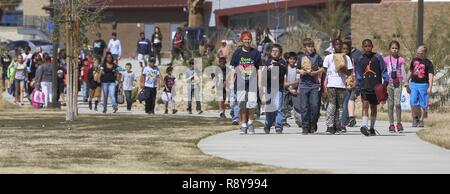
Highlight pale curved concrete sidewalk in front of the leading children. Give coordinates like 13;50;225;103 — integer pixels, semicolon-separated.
198;117;450;174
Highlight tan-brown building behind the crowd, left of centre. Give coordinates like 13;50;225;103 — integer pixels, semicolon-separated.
88;0;211;58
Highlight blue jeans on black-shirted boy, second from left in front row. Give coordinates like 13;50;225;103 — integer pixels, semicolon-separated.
264;89;284;129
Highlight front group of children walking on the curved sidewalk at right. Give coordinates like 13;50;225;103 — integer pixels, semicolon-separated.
221;32;434;136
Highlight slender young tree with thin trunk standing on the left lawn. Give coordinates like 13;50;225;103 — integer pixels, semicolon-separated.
50;0;109;121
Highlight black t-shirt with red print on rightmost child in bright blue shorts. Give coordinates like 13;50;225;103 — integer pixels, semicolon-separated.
409;58;434;83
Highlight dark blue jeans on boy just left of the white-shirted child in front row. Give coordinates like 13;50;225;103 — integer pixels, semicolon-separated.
300;88;320;129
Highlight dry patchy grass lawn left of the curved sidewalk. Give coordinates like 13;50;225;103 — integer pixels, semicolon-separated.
0;111;323;173
